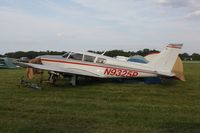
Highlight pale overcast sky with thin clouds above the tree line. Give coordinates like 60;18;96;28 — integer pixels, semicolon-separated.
0;0;200;54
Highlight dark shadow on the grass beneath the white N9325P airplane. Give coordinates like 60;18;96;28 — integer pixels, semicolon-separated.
25;76;177;90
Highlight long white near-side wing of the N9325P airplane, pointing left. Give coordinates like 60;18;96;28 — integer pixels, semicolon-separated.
16;62;102;77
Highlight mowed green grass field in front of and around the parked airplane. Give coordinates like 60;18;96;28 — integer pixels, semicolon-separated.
0;64;200;133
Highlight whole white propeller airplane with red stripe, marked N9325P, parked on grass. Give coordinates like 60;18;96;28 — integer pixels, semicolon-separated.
17;44;184;85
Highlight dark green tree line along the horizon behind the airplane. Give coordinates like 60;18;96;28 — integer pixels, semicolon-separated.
0;49;200;60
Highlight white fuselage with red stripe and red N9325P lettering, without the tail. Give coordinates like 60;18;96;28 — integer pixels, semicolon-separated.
40;52;157;78
